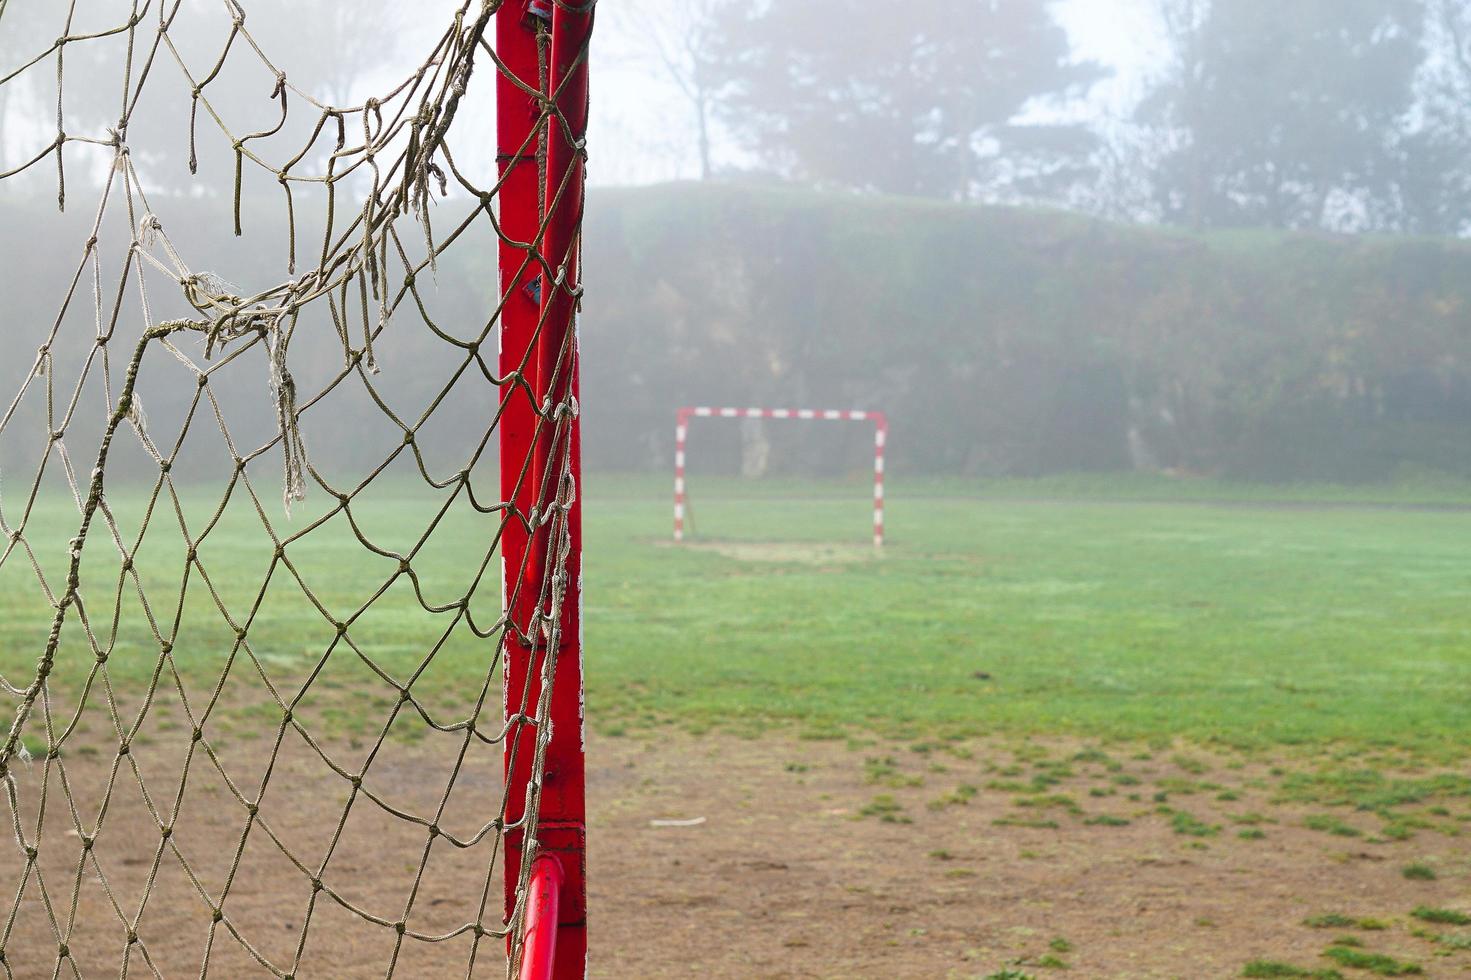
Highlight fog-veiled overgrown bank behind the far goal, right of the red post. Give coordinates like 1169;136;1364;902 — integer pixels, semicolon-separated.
585;185;1471;480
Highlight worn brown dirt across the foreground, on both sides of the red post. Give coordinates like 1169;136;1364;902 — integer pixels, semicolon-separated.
0;721;1471;979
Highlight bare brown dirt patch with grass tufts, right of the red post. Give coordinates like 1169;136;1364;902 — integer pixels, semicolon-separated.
590;737;1471;979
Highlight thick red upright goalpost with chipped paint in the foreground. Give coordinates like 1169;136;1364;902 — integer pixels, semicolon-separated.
496;0;596;980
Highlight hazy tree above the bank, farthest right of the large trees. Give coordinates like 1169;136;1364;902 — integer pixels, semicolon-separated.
1140;0;1424;230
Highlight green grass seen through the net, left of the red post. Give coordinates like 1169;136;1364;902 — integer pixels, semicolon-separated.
0;479;500;737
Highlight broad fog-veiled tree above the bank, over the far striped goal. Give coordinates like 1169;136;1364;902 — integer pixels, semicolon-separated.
716;0;1102;200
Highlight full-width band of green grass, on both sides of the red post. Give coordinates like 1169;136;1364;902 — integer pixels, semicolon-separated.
0;474;1471;753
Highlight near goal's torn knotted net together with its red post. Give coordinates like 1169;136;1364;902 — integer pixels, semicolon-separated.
0;0;593;979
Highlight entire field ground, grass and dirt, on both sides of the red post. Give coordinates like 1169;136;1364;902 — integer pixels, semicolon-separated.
0;474;1471;980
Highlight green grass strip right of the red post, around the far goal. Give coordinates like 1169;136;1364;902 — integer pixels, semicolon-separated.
587;477;1471;755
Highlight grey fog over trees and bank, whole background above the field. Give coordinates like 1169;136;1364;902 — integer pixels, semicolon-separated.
0;0;1471;481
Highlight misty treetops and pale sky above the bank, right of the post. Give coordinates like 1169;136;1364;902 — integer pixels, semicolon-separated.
611;0;1471;234
